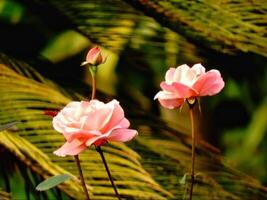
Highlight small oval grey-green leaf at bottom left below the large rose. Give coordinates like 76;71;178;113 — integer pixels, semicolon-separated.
36;174;73;191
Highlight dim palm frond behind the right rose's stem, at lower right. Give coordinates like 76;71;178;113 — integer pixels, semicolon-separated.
124;112;267;200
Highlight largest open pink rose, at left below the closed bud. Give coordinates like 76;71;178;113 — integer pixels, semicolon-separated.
53;100;137;156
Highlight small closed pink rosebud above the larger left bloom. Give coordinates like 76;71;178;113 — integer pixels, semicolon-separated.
81;47;106;66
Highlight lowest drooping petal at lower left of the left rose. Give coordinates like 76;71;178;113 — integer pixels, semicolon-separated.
53;139;87;157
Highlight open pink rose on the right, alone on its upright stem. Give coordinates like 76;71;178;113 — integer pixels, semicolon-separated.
154;64;224;109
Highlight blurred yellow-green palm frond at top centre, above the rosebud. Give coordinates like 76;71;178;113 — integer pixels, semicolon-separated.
17;0;202;65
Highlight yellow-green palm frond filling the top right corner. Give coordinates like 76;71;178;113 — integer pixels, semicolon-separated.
125;0;267;57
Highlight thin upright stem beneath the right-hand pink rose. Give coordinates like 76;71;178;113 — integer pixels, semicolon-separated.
189;106;196;200
